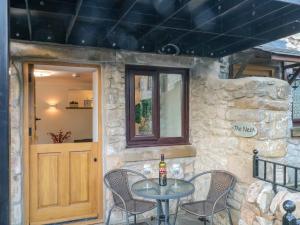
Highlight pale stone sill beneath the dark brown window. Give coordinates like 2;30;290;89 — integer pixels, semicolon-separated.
123;145;196;162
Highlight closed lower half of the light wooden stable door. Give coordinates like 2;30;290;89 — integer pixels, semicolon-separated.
30;142;99;224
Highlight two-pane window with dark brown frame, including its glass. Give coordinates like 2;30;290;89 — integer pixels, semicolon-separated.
126;66;189;147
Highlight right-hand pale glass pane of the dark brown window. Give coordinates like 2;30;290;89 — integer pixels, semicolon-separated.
159;73;182;137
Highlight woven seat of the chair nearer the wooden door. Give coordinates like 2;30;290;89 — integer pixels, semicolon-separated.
116;199;156;214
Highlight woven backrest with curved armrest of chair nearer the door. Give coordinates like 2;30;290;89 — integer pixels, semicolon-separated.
104;169;145;205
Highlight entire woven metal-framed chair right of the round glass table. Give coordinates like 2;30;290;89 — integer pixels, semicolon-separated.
174;170;236;225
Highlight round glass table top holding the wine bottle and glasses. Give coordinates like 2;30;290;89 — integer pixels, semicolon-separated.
131;178;195;200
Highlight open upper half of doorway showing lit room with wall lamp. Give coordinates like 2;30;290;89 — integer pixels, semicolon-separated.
34;65;98;144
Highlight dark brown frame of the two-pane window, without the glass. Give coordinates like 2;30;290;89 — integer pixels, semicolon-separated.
125;66;190;147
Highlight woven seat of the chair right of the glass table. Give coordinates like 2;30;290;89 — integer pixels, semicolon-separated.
180;201;226;217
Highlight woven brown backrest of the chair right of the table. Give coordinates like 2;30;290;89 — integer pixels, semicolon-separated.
207;170;236;205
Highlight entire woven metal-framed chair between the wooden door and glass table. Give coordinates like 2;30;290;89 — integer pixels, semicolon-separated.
104;169;156;225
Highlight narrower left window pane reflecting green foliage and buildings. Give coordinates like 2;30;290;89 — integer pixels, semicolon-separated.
134;75;153;136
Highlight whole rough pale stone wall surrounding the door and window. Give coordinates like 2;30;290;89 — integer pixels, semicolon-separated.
11;40;289;225
